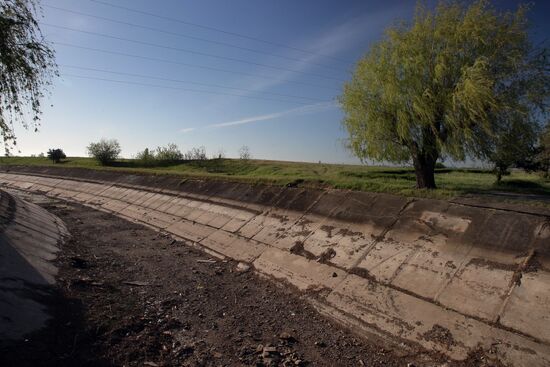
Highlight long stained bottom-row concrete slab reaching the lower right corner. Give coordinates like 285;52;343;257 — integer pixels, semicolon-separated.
326;275;550;367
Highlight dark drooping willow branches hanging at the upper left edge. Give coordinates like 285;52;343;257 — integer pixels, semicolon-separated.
0;0;57;154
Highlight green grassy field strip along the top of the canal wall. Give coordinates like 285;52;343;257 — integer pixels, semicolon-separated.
0;157;550;201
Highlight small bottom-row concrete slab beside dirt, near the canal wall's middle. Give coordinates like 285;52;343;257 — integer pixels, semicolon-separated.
200;230;267;263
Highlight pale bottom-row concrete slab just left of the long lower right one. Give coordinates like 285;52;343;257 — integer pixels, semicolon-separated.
254;248;345;290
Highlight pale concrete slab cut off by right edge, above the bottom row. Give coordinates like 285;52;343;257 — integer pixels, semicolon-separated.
500;271;550;348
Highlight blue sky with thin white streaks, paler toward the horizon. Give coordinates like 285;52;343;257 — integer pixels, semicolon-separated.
10;0;550;163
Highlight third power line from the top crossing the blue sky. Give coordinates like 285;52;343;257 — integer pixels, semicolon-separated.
41;22;341;81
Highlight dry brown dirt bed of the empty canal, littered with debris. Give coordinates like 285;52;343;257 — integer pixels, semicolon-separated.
0;198;494;366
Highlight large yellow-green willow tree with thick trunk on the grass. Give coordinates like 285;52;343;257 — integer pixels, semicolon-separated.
340;0;549;188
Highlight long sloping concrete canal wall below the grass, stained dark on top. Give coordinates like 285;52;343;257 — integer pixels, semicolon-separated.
0;168;550;365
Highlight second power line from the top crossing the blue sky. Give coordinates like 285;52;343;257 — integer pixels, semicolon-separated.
43;4;345;71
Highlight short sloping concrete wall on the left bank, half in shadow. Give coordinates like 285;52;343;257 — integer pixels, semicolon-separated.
0;191;67;346
